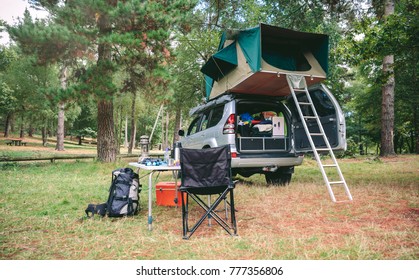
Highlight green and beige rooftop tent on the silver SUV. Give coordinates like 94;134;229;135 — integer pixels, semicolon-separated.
201;24;329;99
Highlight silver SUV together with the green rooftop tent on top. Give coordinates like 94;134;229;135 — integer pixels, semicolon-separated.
179;24;346;184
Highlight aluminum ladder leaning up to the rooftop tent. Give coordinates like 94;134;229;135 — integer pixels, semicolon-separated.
286;74;352;202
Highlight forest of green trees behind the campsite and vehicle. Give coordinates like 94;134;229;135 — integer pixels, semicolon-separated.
0;0;419;162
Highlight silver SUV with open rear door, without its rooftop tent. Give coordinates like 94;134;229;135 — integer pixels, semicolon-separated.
179;84;346;185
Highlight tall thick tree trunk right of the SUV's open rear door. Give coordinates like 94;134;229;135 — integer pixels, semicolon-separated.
380;0;395;156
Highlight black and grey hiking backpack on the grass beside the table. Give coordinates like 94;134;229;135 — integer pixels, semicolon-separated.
85;168;141;218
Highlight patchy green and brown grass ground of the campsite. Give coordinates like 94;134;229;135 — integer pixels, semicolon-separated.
0;138;419;260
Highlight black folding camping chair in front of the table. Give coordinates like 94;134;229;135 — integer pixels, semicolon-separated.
180;145;237;239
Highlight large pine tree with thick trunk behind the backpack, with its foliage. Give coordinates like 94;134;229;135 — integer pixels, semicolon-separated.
10;0;196;162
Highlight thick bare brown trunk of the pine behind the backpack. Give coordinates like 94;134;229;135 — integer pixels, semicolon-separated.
97;100;116;162
